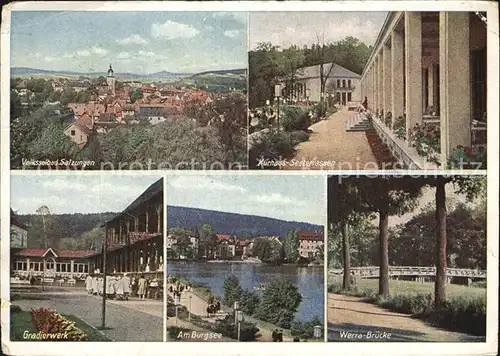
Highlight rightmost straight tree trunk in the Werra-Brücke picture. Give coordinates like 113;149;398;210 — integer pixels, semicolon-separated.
434;177;446;307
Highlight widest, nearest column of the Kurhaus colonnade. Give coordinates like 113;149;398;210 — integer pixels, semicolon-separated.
439;12;471;162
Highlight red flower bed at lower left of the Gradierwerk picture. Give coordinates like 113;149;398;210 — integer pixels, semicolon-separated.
31;308;88;341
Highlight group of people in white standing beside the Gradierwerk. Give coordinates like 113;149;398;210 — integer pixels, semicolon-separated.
85;273;147;300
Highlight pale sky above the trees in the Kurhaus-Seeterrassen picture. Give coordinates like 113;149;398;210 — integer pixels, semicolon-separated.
249;12;387;49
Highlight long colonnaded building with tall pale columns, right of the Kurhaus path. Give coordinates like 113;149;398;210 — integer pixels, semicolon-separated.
361;12;487;168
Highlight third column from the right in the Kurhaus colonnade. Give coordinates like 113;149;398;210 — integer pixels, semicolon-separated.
391;31;404;120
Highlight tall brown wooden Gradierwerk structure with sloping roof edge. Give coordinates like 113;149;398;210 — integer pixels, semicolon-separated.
90;179;164;274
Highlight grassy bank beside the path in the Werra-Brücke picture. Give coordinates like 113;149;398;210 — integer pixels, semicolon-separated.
328;280;486;336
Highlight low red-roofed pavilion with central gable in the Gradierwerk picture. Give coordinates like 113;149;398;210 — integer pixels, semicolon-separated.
11;248;95;279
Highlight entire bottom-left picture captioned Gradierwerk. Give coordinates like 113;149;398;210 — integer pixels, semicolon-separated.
10;173;165;342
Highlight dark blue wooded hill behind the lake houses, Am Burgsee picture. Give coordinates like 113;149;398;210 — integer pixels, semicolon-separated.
167;206;323;238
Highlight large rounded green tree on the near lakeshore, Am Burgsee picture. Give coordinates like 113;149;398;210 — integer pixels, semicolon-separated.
256;279;302;329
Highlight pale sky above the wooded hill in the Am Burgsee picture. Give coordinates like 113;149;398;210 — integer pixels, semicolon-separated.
166;174;326;225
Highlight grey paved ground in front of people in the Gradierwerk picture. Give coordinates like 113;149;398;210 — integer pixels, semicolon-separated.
13;293;163;342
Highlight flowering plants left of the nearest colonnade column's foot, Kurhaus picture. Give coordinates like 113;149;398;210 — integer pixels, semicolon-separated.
410;123;441;164
